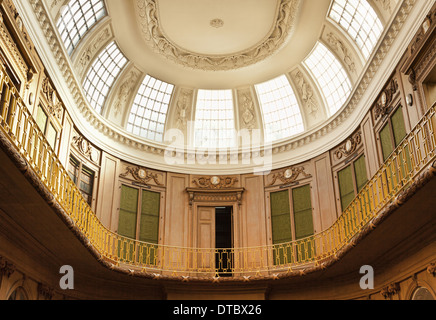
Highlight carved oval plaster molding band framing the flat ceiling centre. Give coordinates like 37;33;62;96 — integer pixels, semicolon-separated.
136;0;302;71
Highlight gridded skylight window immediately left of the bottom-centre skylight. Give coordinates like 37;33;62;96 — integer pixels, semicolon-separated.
127;75;174;142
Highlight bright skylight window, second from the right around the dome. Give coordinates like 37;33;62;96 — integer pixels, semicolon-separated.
304;43;351;116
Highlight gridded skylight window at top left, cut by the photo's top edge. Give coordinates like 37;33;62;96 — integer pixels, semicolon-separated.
57;0;106;55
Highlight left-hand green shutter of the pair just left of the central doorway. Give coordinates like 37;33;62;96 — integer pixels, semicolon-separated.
118;185;139;239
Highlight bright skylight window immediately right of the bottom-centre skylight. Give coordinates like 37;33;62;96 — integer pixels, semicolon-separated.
256;75;304;142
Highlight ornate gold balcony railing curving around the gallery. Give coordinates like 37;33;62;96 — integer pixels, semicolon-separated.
0;65;436;277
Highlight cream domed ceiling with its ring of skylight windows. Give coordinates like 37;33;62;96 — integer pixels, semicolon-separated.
29;0;413;174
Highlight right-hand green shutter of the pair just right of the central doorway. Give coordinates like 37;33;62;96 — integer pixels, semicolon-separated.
292;185;314;240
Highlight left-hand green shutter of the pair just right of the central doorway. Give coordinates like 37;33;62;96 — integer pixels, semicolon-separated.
270;190;294;265
